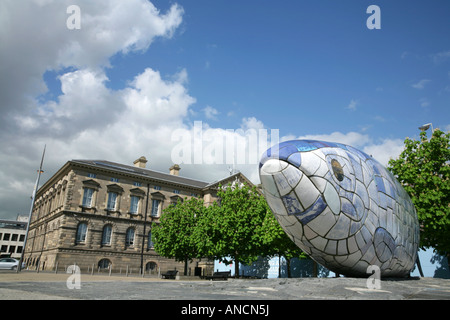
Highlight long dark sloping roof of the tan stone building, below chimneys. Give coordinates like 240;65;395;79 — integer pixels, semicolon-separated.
70;160;209;189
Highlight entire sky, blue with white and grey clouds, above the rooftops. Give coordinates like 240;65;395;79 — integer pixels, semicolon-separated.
0;0;450;219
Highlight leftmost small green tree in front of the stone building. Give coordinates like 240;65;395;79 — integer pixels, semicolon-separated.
152;198;206;275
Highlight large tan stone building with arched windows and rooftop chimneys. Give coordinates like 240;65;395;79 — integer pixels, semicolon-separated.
24;157;251;272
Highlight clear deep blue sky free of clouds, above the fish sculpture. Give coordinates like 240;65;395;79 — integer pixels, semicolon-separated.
108;0;450;139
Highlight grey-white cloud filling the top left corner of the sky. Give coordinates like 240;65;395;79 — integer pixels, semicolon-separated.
0;0;183;127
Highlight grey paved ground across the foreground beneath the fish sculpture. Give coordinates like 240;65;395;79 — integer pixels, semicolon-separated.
0;271;450;300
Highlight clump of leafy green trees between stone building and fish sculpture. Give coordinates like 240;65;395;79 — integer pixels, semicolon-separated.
152;184;303;276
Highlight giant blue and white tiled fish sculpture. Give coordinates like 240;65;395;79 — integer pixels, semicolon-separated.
259;140;419;277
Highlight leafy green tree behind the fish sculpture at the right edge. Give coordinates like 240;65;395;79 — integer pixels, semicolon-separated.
388;129;450;268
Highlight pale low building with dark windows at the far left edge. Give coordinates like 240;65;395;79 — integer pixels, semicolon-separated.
0;215;28;259
